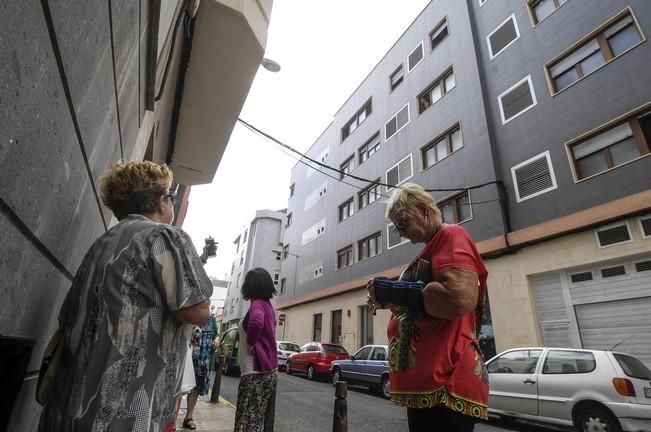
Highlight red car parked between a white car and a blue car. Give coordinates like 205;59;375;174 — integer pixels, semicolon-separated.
286;342;348;380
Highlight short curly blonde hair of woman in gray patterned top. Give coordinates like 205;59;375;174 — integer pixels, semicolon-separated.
99;161;173;220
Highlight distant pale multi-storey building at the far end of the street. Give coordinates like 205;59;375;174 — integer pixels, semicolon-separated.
221;209;287;331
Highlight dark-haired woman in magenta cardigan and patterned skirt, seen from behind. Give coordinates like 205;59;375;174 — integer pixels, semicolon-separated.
234;267;278;432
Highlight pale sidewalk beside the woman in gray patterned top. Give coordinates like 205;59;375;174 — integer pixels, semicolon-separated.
176;395;235;432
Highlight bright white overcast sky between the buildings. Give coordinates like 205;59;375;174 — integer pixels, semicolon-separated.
183;0;429;288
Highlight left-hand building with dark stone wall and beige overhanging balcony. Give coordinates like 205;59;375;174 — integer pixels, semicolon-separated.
0;0;272;431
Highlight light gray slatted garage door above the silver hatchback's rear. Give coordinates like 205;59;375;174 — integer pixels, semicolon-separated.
575;297;651;367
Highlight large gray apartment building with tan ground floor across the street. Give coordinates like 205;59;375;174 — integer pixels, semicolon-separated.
276;0;651;363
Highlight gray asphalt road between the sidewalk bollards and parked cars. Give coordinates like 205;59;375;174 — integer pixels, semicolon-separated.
216;372;567;432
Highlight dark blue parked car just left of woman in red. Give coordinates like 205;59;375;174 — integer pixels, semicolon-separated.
330;345;391;399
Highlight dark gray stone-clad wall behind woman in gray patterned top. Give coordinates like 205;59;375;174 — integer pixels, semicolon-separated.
0;0;168;431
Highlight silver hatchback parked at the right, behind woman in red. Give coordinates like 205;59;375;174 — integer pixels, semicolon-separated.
487;347;651;432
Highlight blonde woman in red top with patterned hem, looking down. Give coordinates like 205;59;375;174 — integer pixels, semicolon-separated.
368;183;488;432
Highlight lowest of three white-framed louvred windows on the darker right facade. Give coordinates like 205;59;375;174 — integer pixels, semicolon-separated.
511;150;557;202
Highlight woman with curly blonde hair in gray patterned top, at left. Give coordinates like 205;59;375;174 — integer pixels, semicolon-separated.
39;162;212;432
